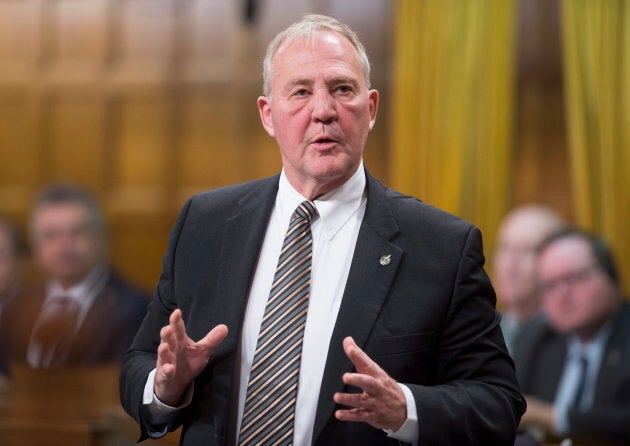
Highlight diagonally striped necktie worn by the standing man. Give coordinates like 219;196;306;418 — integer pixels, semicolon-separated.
239;201;317;445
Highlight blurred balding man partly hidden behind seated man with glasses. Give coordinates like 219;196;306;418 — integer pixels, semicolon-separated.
492;205;565;354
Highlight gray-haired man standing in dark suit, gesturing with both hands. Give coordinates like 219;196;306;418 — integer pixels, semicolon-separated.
121;15;524;445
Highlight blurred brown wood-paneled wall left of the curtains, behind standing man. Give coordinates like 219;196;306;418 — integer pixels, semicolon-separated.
0;0;391;289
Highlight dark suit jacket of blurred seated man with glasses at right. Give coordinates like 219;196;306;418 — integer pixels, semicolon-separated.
515;303;630;444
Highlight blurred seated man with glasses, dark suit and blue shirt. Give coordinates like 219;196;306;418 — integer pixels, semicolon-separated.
516;229;630;445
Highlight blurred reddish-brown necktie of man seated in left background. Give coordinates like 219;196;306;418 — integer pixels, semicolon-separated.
33;296;80;367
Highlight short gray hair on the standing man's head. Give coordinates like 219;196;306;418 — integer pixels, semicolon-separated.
263;14;370;96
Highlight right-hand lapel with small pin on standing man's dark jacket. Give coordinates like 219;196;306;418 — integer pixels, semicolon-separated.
313;172;403;443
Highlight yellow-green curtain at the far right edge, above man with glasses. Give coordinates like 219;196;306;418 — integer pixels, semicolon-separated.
562;0;630;289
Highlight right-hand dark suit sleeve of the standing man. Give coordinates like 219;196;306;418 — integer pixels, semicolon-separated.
408;227;525;445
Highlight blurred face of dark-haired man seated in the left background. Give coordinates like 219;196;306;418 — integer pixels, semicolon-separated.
33;203;105;288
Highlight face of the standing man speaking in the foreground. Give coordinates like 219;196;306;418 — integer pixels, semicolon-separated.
258;32;378;198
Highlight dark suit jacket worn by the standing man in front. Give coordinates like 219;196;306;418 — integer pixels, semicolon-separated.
121;174;524;445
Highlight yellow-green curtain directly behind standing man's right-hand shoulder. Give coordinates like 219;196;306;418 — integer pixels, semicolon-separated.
389;0;516;251
